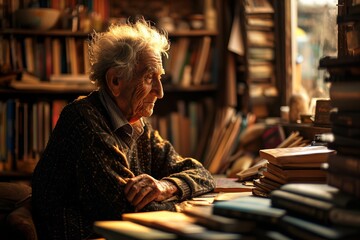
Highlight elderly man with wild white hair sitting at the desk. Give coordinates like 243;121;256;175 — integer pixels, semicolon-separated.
32;19;215;239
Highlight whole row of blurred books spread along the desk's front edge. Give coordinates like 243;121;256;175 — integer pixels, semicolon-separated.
94;188;360;240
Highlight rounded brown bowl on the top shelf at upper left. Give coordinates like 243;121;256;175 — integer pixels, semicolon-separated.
14;8;60;30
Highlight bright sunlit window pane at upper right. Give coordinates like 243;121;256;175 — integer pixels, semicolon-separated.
293;0;338;99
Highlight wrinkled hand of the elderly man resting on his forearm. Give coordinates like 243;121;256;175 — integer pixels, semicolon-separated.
124;174;178;211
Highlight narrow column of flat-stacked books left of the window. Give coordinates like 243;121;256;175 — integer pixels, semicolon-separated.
240;0;282;118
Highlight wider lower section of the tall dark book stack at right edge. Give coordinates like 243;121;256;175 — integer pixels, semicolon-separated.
320;56;360;197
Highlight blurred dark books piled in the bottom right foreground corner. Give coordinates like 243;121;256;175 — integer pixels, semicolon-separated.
270;183;360;239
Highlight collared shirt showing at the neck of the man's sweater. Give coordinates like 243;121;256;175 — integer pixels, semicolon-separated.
99;89;144;147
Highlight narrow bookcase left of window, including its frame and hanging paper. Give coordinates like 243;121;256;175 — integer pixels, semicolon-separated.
219;0;291;118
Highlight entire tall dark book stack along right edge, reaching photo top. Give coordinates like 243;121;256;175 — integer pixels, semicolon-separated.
319;1;360;197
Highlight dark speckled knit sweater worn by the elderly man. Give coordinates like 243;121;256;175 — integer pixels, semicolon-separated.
32;91;215;240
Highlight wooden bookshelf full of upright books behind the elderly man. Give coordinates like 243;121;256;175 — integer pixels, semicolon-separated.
0;0;223;176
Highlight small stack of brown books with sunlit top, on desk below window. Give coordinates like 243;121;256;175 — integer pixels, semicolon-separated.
253;146;335;197
